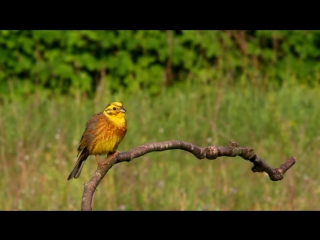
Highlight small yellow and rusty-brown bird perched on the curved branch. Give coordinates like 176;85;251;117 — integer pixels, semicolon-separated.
68;102;127;180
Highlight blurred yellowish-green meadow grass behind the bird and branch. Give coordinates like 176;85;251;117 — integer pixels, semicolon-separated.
0;81;320;210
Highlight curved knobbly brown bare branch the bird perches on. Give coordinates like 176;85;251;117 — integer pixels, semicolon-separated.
81;140;296;211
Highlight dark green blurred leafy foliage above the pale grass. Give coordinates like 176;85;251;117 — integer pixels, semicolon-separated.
0;30;320;100
